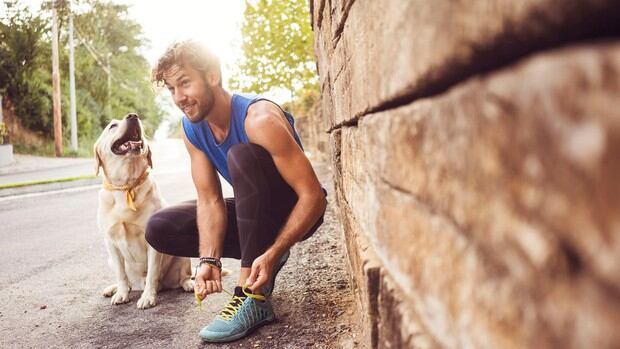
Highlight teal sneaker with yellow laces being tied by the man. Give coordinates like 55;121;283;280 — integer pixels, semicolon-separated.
200;286;275;343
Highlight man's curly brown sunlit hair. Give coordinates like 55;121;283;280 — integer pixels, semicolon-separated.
151;40;222;87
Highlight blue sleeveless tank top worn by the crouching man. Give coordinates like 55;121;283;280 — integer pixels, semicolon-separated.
183;93;303;184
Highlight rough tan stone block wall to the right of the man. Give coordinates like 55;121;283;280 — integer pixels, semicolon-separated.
311;0;620;348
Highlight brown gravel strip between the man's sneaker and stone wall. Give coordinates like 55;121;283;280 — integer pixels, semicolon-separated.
204;164;362;349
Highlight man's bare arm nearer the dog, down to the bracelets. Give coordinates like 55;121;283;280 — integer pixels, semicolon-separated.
183;135;227;258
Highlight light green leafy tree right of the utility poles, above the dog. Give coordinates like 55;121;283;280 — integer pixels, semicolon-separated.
63;1;162;138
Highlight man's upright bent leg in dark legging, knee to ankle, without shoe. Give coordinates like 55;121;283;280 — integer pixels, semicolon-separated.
228;143;323;292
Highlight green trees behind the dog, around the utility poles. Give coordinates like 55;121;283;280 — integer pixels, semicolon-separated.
0;0;162;154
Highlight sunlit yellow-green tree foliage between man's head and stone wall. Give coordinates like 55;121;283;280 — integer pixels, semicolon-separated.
229;0;317;95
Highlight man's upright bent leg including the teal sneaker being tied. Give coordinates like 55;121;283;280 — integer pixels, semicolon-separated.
200;144;322;342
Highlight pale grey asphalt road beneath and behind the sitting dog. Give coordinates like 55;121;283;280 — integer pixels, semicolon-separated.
0;140;241;348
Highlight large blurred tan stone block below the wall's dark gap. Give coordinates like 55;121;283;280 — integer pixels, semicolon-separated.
339;42;620;348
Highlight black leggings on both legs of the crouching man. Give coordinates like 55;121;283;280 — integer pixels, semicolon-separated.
146;143;327;267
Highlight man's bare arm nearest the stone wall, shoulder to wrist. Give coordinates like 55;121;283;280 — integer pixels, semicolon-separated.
245;101;327;256
